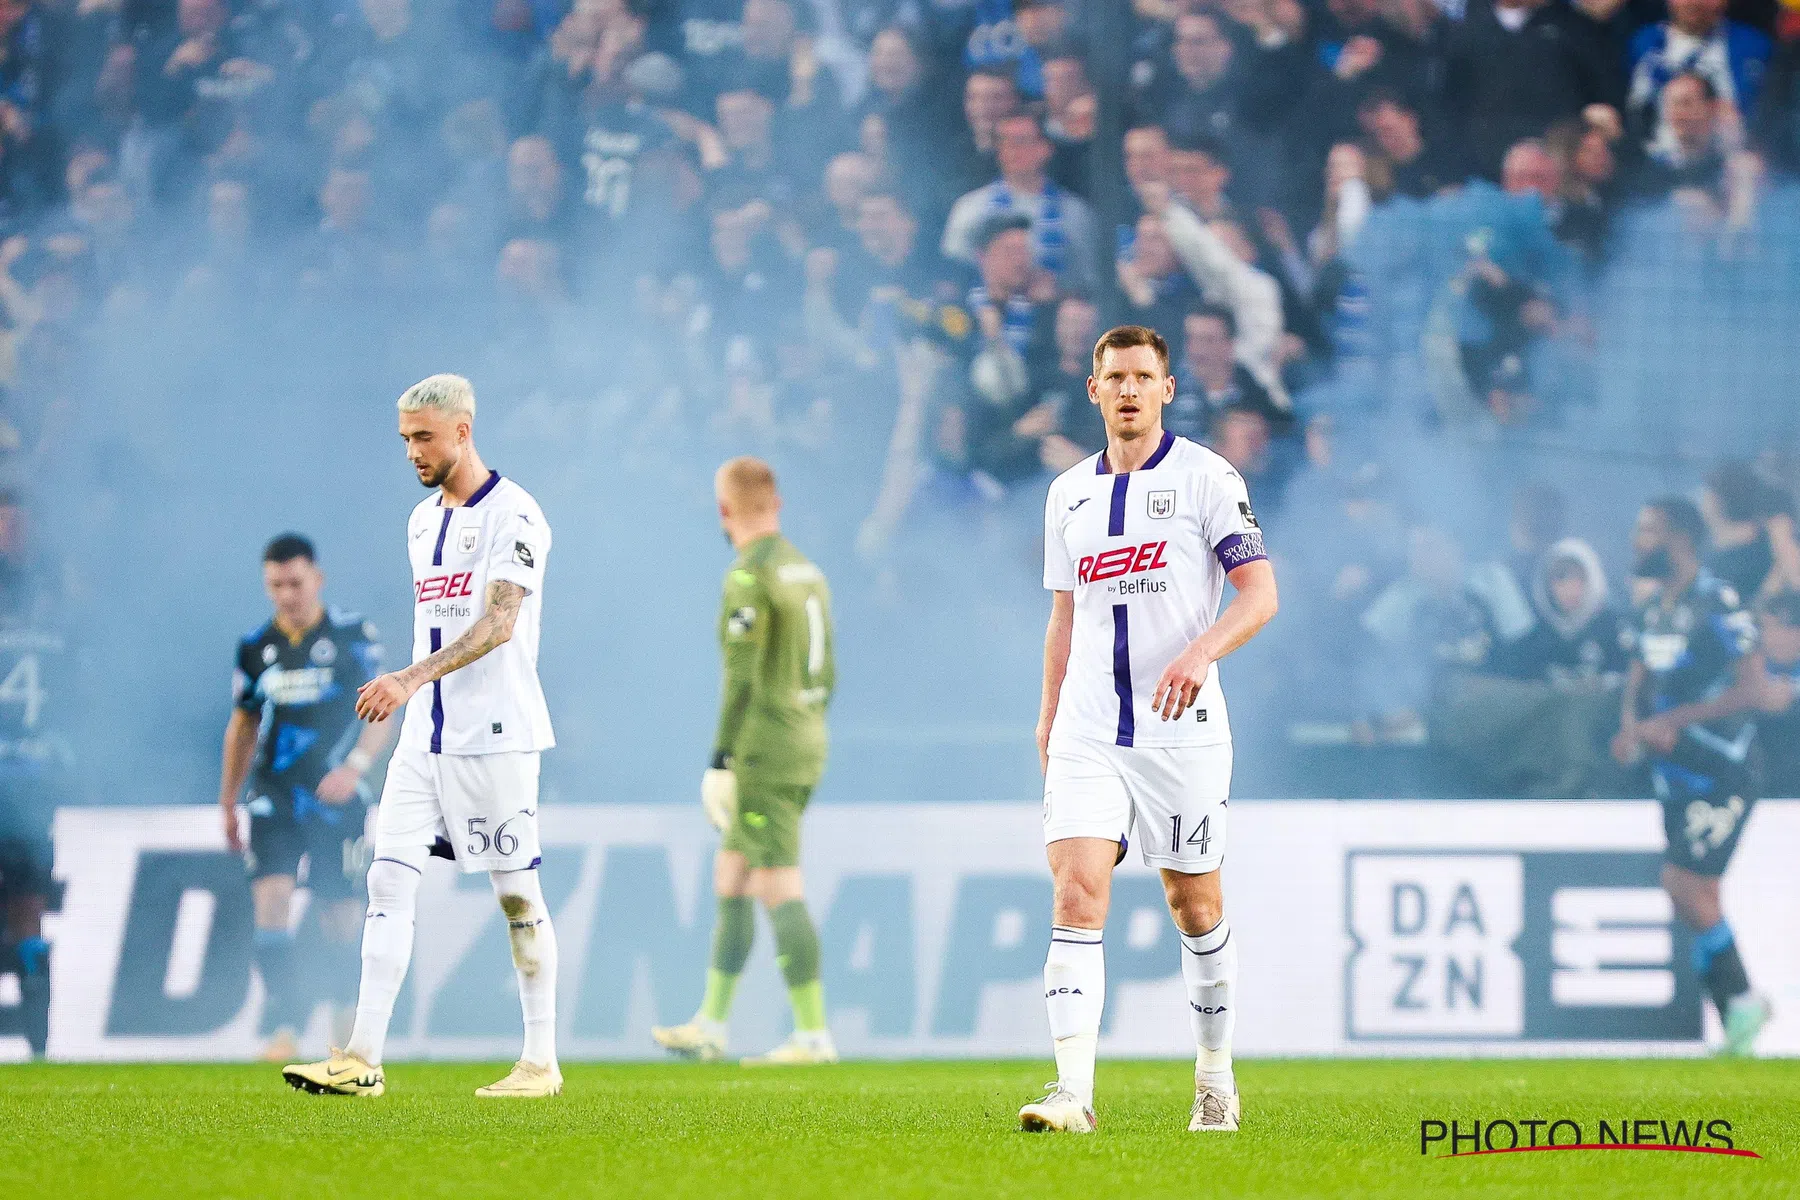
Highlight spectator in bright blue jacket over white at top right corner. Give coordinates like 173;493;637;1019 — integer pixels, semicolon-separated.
1625;0;1771;153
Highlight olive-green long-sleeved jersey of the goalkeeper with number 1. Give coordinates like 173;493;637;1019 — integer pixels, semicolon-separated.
713;533;837;788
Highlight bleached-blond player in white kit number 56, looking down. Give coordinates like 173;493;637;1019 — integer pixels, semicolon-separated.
281;374;562;1099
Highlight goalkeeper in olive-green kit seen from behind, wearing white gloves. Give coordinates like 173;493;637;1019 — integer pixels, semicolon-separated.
650;459;837;1067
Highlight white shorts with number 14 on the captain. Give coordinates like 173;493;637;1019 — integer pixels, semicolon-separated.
1044;738;1231;874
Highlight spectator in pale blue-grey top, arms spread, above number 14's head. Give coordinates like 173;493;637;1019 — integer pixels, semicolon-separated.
943;115;1098;293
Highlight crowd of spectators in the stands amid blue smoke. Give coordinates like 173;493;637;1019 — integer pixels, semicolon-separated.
0;0;1800;795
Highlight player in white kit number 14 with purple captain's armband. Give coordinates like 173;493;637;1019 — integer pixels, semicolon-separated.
1019;326;1276;1133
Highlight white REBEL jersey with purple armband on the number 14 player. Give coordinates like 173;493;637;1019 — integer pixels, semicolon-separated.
1044;432;1265;748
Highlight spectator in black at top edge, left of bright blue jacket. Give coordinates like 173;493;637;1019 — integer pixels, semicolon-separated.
1444;0;1620;178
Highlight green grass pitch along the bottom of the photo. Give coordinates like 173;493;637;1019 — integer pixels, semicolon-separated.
0;1060;1800;1200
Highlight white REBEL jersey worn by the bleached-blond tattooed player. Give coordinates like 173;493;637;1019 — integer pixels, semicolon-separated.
400;471;556;754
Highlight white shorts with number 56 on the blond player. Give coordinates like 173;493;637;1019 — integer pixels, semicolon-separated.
374;748;544;873
